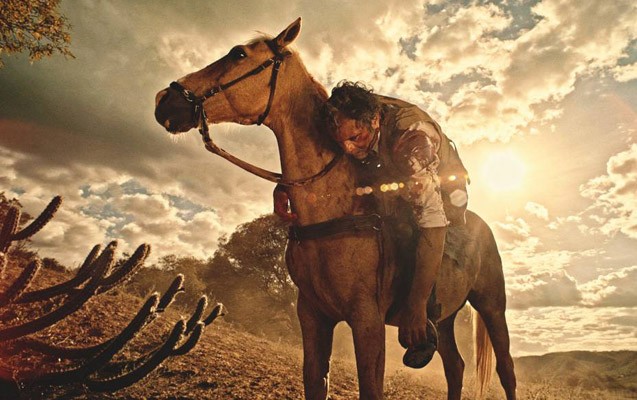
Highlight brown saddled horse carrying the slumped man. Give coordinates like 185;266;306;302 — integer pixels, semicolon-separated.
155;18;516;399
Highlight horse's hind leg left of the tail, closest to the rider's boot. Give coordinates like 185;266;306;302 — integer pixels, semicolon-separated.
438;312;464;400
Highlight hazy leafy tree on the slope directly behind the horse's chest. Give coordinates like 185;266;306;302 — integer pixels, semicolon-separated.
202;214;300;341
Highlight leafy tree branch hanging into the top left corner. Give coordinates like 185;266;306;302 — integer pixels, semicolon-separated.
0;0;75;68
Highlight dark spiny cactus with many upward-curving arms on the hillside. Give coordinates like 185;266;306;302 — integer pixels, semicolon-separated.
0;196;223;396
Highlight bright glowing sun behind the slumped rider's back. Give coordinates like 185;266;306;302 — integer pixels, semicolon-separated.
482;150;526;192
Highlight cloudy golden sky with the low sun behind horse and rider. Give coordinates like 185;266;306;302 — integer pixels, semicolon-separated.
0;0;637;356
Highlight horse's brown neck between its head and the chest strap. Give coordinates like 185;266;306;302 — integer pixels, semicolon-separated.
271;69;355;225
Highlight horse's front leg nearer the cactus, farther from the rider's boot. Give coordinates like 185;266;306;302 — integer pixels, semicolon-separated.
297;291;336;400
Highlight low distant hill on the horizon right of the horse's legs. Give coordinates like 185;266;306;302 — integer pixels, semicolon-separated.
515;351;637;395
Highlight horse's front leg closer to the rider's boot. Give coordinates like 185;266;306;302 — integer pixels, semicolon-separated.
348;303;385;400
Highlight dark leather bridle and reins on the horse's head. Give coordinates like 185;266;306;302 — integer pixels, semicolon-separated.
170;40;343;186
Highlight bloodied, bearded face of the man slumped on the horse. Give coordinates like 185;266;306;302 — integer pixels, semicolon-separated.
333;114;380;160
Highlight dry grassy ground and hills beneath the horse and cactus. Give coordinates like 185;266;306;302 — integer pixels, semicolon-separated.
0;266;637;400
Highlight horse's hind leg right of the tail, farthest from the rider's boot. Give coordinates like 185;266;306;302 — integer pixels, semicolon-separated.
469;290;516;400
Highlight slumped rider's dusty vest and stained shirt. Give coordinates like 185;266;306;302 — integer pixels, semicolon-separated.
374;96;467;228
